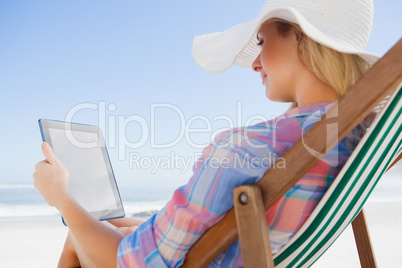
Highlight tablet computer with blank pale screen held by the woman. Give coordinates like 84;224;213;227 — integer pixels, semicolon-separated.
39;119;125;224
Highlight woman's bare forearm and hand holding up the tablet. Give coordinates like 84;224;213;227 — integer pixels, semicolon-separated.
33;142;126;267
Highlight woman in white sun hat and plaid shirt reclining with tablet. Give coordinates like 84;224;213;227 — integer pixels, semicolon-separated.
33;0;376;267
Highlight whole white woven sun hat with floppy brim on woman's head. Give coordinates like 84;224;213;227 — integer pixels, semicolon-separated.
192;0;379;73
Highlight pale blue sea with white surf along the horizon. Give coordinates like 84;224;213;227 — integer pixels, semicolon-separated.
0;163;402;222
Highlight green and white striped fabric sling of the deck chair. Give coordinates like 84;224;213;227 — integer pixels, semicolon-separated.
274;88;402;267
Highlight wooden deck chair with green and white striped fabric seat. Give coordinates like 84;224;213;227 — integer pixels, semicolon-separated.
183;40;402;268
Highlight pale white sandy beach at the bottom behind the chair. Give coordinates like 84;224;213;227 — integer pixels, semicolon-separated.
0;202;402;268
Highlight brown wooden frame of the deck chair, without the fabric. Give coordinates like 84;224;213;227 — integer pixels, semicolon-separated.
183;40;402;268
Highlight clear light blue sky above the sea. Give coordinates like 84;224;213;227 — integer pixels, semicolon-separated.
0;0;402;188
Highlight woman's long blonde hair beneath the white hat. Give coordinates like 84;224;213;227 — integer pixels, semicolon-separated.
267;18;370;109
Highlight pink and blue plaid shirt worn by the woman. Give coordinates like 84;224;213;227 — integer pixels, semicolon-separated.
117;102;368;267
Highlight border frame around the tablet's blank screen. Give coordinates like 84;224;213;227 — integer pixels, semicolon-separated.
38;119;125;225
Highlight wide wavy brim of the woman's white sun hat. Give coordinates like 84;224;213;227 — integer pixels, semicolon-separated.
192;8;380;73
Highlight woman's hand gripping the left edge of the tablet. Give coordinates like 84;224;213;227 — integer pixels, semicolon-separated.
33;142;71;209
